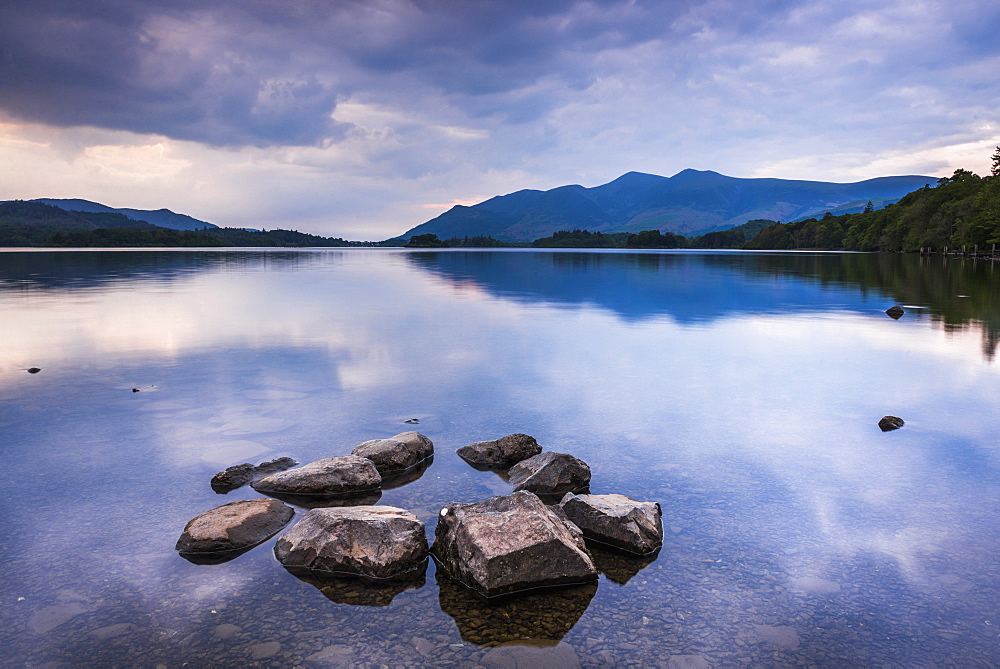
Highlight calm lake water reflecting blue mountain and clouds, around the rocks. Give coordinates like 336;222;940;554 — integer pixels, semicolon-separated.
0;249;1000;667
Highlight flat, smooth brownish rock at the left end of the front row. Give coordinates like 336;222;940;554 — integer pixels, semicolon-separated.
174;498;295;554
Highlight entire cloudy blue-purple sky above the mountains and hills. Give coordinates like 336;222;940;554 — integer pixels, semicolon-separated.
0;0;1000;240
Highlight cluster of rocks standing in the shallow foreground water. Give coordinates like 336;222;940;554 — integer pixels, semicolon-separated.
177;432;663;606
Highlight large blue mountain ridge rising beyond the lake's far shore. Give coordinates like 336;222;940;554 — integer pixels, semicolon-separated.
399;169;938;242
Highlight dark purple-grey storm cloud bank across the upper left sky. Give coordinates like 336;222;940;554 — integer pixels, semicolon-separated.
0;0;704;145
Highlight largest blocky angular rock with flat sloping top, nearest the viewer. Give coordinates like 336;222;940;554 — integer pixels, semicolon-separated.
433;491;597;597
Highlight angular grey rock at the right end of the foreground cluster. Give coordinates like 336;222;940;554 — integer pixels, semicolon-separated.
559;492;663;555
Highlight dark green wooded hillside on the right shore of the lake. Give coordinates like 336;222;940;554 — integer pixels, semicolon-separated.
745;169;1000;251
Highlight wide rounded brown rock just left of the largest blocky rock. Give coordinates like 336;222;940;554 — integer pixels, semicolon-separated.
274;506;427;578
